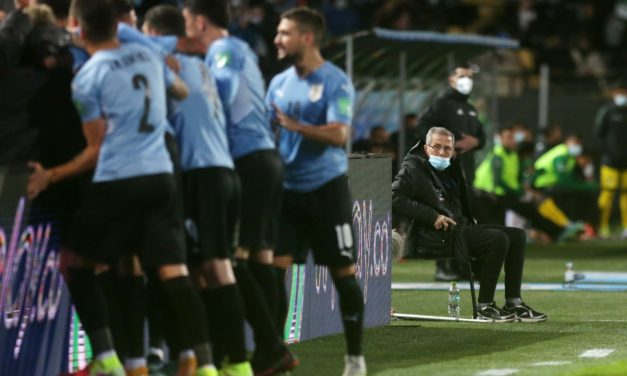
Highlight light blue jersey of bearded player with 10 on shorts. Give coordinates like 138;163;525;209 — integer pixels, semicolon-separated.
266;61;355;192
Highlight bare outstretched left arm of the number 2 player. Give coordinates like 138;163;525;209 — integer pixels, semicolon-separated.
26;118;106;199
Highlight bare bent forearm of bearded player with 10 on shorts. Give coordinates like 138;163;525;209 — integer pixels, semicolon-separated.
274;105;348;146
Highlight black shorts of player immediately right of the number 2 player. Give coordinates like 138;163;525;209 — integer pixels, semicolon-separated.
183;167;241;266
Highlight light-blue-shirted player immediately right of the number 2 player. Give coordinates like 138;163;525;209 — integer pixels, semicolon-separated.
143;6;252;376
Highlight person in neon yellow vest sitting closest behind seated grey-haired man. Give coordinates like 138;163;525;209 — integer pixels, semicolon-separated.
474;127;572;240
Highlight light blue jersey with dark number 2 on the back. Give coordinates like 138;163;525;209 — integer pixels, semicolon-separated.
72;44;172;182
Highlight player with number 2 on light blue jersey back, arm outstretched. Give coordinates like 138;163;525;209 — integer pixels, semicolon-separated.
28;0;217;376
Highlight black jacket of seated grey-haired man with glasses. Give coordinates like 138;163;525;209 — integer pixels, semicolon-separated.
392;142;474;254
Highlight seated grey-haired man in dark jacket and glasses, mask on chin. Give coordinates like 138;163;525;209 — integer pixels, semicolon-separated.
392;127;547;322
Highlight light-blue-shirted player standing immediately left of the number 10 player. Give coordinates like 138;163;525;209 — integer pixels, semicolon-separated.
183;0;298;375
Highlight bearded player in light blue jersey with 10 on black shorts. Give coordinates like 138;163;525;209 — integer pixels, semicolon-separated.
266;7;366;376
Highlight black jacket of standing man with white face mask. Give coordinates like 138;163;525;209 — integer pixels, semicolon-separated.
416;87;486;182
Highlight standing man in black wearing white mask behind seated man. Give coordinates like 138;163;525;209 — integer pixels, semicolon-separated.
416;63;486;281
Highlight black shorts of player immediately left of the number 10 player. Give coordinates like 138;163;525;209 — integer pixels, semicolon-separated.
235;150;283;252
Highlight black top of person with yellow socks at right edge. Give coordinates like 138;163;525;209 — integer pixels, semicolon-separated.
595;104;627;169
